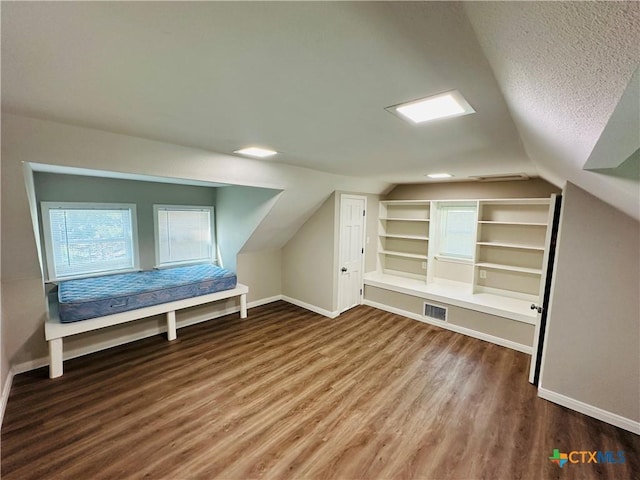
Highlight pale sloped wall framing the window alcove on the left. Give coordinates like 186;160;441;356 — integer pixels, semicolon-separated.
0;115;387;372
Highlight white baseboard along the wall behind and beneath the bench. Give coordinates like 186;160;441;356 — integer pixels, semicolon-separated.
10;295;282;376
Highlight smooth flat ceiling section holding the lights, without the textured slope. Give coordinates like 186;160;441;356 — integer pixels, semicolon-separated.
2;2;537;182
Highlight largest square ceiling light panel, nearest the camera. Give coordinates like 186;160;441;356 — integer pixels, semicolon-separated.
385;90;475;123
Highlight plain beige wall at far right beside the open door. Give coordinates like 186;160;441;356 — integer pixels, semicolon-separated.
540;183;640;428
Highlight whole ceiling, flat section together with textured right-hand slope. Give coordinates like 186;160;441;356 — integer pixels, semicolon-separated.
2;2;640;218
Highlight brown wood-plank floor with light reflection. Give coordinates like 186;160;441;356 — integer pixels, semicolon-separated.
2;302;640;480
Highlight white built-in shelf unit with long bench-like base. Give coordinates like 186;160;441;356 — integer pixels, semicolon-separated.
364;195;555;353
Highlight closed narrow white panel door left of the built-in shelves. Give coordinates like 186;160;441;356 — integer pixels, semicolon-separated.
338;194;367;313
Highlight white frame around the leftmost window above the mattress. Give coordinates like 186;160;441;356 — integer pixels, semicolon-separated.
40;202;140;282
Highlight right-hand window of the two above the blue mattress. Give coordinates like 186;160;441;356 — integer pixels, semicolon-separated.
153;205;215;267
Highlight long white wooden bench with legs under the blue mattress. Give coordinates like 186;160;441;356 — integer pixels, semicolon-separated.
44;283;249;378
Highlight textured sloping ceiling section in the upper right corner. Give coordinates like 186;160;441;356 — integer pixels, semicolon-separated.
465;2;640;219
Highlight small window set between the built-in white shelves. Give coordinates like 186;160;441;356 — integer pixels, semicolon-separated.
438;203;476;260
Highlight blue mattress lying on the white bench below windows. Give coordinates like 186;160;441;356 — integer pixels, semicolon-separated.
58;264;237;323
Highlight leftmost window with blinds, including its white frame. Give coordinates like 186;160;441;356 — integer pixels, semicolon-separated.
41;202;138;280
